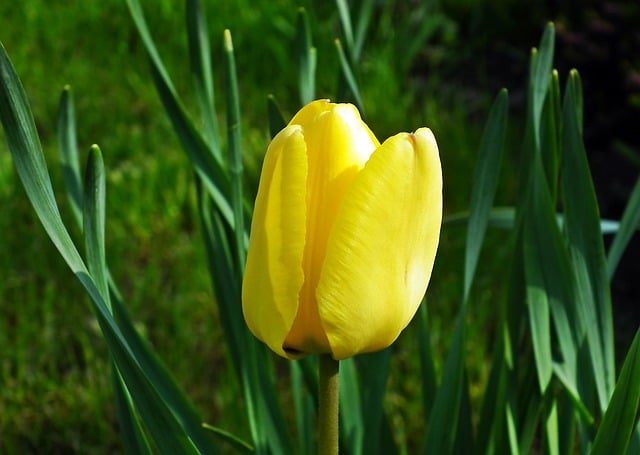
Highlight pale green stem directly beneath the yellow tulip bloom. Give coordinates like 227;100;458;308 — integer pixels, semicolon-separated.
318;354;340;455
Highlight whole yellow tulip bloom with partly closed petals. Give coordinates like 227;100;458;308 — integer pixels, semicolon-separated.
242;100;442;360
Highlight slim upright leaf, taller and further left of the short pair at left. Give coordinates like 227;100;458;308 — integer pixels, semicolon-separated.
57;85;83;226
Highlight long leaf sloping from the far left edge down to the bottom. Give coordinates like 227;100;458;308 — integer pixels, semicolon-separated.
0;41;216;453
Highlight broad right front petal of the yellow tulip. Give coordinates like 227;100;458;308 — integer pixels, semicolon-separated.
316;128;442;359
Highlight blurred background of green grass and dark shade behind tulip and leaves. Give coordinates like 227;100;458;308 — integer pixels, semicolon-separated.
0;0;640;454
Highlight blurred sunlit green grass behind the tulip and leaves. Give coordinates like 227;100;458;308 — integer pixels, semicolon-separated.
0;0;524;453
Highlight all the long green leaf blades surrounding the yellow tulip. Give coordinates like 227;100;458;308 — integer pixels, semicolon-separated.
0;0;640;454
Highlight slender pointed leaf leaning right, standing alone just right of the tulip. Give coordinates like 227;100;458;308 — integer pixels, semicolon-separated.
463;89;508;304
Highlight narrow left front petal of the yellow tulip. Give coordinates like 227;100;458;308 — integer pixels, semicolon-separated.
242;126;307;357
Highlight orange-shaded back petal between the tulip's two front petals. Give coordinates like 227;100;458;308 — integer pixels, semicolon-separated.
285;100;378;353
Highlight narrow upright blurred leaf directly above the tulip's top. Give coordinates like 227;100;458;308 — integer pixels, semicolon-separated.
295;8;316;106
